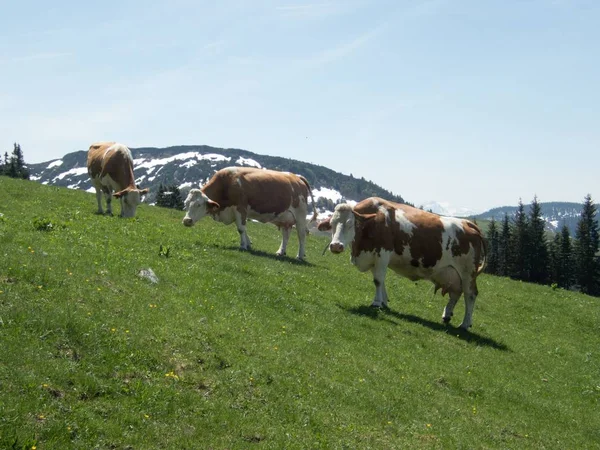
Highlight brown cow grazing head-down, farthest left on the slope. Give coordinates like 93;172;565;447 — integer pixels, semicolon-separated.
87;142;148;217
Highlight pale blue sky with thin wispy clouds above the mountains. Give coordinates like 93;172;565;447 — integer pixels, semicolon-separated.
0;0;600;211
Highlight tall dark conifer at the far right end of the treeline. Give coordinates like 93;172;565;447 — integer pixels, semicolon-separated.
575;194;600;295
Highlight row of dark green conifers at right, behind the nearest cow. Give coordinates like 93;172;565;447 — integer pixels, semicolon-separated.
486;194;600;296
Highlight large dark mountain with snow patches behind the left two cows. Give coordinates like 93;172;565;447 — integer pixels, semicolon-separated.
27;145;404;214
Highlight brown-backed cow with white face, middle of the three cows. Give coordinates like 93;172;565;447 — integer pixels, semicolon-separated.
183;167;317;259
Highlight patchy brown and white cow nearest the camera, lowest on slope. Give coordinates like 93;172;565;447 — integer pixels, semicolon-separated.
319;197;486;329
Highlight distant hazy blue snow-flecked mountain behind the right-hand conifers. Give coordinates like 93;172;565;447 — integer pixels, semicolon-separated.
473;202;600;236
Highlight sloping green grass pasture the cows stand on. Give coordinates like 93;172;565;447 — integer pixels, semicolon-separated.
0;177;600;449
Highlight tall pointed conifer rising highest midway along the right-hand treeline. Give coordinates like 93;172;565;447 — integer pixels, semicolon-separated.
527;196;548;283
